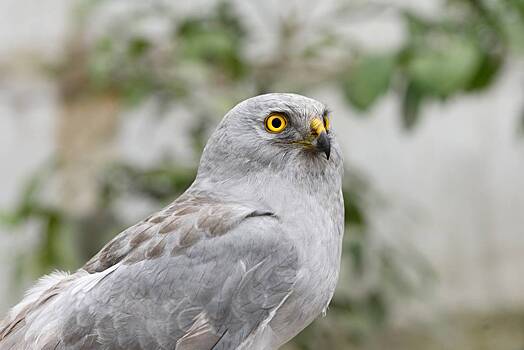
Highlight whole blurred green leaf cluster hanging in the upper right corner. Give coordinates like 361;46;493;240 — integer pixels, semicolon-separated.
342;0;524;129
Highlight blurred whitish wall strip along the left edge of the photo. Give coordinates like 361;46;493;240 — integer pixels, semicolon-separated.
0;0;72;314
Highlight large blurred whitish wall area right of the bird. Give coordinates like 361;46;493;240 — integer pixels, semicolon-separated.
325;62;524;320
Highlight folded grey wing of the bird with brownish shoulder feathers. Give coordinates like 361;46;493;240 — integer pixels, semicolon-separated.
0;194;298;350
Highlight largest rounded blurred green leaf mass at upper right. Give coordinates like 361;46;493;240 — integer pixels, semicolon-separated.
402;7;502;98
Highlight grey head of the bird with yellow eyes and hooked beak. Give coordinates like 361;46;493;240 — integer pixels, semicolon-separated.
201;93;342;182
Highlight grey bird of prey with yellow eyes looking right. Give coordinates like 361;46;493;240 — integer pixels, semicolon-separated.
0;93;344;350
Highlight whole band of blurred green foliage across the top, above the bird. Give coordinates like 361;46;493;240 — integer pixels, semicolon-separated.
77;0;524;129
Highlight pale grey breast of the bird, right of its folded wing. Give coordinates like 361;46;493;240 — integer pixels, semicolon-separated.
270;190;343;345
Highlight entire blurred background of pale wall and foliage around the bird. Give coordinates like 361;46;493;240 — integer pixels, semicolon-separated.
0;0;524;350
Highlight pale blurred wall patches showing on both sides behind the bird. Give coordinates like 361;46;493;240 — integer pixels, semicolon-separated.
0;0;524;326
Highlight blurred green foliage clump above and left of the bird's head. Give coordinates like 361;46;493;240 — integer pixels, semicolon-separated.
81;2;249;105
